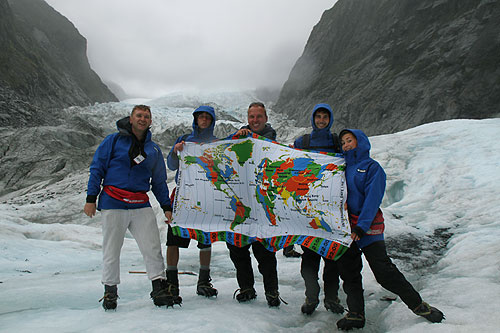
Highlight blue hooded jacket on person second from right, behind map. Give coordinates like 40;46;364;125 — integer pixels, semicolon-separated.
293;103;335;153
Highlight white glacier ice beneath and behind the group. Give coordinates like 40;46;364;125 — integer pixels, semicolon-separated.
0;93;500;332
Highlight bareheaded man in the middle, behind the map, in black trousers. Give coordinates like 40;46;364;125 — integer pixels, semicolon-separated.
226;102;281;307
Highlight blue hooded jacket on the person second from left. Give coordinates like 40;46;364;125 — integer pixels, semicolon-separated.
167;105;217;182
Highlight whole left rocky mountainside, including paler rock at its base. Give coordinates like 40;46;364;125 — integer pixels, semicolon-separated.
0;0;117;196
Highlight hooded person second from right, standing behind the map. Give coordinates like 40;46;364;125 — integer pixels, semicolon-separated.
293;103;344;315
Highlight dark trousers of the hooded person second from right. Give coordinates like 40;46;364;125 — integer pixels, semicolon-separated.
300;246;339;301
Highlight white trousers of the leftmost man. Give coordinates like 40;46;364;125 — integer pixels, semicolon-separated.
102;207;165;286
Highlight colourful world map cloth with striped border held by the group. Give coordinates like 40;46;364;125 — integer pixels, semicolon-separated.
171;134;351;260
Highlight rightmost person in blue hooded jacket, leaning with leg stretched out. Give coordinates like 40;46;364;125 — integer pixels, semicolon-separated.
337;129;444;330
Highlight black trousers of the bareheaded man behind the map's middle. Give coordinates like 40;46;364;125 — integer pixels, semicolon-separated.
226;242;278;293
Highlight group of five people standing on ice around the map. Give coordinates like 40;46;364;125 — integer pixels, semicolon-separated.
84;102;444;330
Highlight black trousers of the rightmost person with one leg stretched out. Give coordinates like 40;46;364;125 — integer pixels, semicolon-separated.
338;241;422;314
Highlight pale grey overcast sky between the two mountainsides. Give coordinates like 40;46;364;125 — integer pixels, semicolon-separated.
46;0;335;97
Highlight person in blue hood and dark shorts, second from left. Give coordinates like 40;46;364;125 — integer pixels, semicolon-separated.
167;105;217;304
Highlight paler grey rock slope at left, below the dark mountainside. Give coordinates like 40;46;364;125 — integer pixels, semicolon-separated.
0;115;103;196
